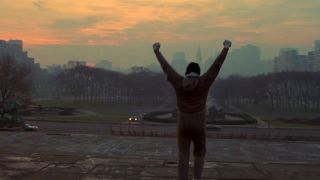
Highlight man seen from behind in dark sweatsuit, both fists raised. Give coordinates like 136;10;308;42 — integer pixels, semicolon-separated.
153;40;232;180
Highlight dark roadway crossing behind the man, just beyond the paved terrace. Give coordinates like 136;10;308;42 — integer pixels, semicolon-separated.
26;121;320;140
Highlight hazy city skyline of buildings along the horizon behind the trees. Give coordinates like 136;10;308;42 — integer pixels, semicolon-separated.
0;40;320;77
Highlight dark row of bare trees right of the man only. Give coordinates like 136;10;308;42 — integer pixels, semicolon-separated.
211;72;320;111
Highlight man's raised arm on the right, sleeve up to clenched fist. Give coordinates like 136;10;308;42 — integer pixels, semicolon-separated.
202;40;232;85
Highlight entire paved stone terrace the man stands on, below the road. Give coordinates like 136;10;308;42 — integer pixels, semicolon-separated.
0;132;320;180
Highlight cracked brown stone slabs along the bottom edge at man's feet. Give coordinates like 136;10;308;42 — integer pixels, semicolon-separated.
0;153;320;180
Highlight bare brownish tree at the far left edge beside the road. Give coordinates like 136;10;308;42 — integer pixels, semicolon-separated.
0;55;31;118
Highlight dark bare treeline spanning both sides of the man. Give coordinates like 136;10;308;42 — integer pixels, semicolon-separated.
35;66;320;110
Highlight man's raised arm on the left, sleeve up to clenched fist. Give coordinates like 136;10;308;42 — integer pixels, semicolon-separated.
153;43;183;83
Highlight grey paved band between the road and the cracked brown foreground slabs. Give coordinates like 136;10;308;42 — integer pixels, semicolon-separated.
0;132;320;163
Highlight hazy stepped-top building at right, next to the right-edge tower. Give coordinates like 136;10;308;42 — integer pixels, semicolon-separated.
274;48;310;72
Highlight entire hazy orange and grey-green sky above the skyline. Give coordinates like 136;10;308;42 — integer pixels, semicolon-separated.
0;0;320;66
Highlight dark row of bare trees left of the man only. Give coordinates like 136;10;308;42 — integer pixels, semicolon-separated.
37;66;172;104
